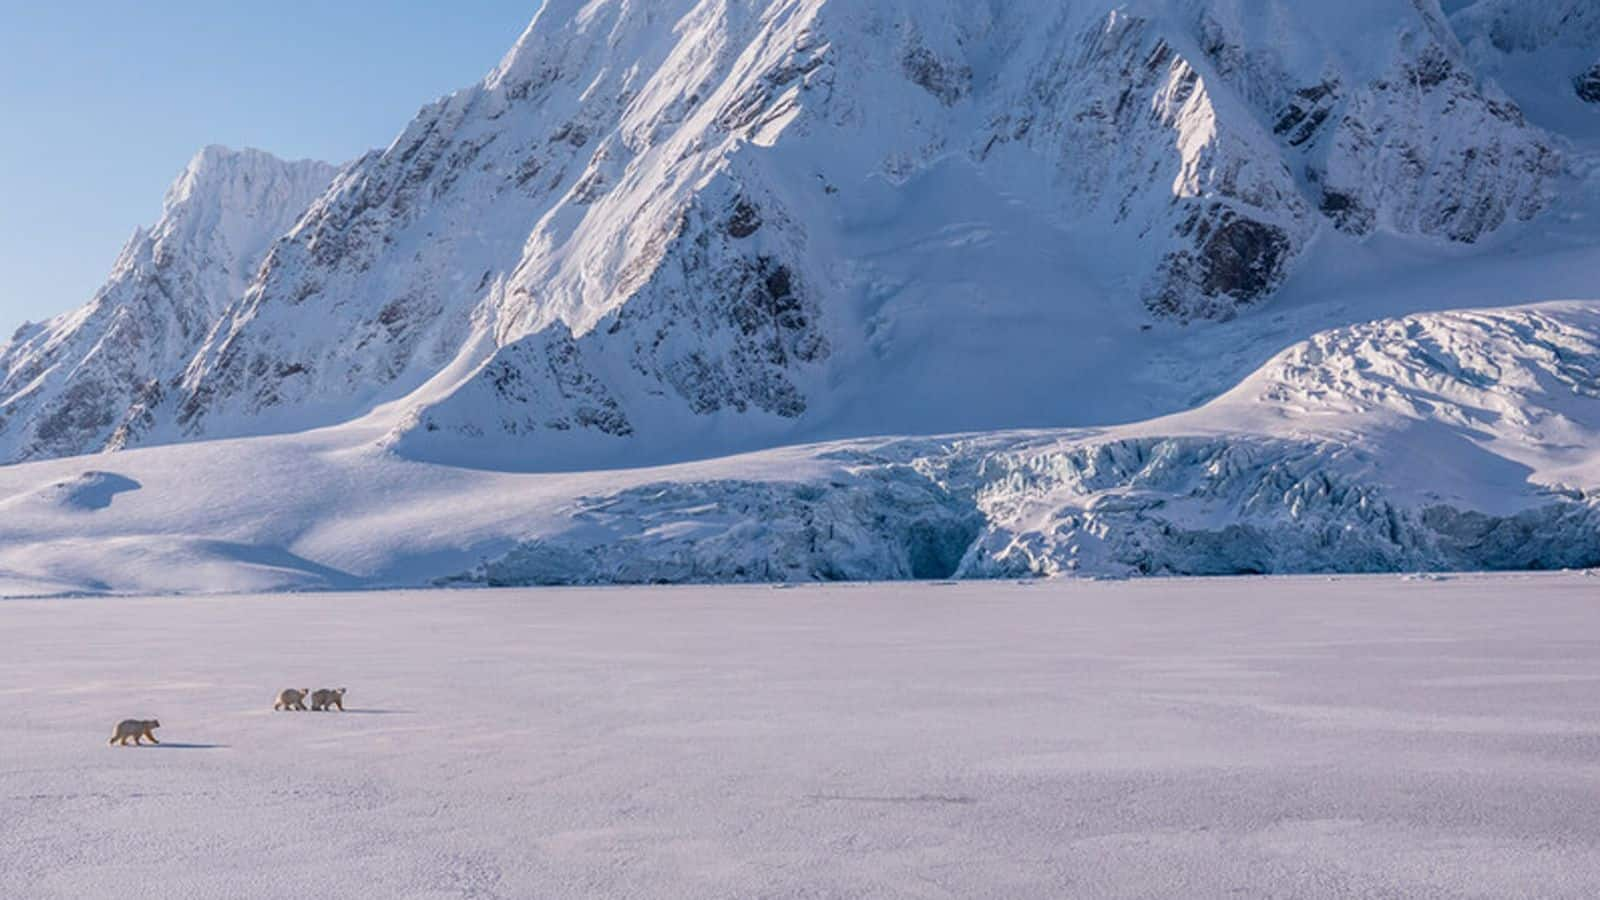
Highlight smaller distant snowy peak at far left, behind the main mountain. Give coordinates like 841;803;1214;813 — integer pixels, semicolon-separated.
0;147;333;463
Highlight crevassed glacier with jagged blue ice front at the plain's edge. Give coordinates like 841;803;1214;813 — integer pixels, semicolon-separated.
460;304;1600;585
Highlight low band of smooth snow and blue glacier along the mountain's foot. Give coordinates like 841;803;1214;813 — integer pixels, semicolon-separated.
0;301;1600;593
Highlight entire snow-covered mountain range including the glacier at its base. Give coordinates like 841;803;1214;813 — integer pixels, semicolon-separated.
0;0;1600;593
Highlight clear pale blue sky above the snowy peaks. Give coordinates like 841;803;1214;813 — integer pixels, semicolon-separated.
0;0;541;343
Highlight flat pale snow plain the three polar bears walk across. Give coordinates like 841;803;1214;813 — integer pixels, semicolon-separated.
9;573;1600;900
